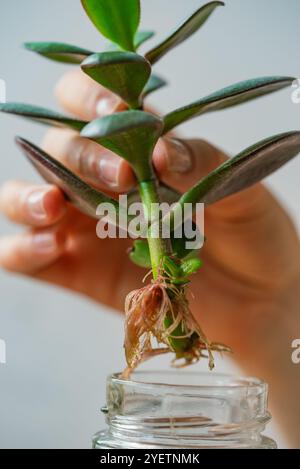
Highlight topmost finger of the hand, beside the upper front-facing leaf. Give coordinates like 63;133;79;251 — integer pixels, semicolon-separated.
55;70;126;121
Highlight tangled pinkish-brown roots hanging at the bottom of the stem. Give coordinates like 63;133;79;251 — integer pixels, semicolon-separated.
123;270;230;377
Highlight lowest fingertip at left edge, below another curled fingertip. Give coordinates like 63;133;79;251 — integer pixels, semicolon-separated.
0;229;66;274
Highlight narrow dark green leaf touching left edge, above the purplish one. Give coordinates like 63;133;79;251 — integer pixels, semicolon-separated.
0;103;87;130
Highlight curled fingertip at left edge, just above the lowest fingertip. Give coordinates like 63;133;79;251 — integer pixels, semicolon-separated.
0;181;66;227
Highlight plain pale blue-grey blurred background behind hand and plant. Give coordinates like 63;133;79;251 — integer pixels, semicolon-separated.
0;0;300;448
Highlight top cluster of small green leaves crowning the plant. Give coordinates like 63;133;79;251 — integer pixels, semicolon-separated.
25;0;223;109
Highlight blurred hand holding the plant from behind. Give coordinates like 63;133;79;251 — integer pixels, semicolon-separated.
0;67;300;444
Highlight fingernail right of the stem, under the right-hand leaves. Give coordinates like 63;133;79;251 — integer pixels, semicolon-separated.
165;139;192;173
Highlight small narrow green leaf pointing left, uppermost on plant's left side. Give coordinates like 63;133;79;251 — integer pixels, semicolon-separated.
24;42;93;64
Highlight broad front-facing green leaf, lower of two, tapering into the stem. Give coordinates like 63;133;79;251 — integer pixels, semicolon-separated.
81;111;163;182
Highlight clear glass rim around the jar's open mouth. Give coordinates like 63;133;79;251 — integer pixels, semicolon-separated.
108;369;267;392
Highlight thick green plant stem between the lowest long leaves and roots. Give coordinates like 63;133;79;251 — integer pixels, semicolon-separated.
139;180;169;279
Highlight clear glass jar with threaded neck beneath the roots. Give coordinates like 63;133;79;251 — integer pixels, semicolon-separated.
93;370;276;449
